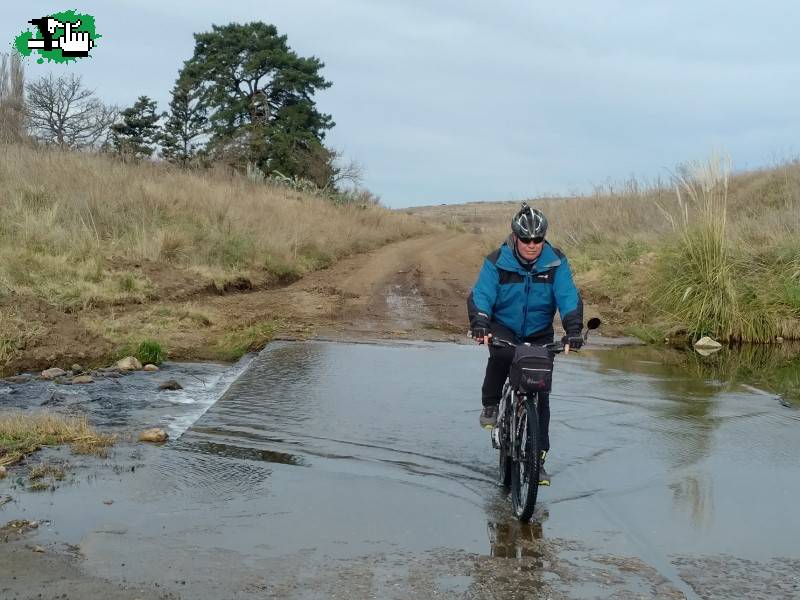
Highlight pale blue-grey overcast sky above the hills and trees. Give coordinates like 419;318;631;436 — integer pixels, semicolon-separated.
0;0;800;207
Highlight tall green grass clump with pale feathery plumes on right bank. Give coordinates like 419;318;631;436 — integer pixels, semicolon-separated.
652;158;787;342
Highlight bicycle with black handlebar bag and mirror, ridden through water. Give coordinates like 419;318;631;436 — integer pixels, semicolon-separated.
482;318;600;522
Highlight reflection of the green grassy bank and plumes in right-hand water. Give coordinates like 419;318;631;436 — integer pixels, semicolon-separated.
593;344;800;528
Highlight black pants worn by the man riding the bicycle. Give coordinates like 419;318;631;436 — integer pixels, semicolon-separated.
481;321;553;450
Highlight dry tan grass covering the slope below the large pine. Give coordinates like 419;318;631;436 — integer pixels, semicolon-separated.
0;145;426;309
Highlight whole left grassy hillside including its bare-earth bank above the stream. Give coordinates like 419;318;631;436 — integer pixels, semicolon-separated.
0;145;431;373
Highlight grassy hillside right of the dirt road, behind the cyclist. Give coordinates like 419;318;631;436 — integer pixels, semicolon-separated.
408;159;800;342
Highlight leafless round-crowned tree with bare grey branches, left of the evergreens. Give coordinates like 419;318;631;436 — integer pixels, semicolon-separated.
27;73;118;149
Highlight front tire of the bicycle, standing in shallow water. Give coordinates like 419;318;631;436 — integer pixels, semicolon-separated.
511;399;542;523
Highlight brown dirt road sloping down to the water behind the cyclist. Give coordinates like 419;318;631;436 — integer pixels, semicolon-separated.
260;233;483;340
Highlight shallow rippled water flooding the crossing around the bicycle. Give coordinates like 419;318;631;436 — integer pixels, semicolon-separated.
0;342;800;599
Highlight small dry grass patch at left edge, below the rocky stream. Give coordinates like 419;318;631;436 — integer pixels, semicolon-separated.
0;412;114;465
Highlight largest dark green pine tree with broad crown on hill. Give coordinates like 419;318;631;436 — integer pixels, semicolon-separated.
181;22;334;187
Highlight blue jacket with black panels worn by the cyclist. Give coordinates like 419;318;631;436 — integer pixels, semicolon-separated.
467;239;583;341
